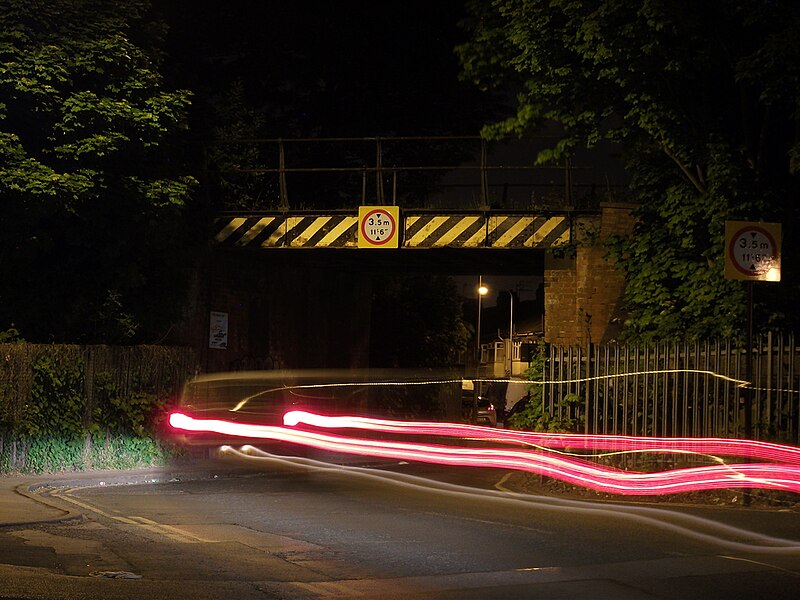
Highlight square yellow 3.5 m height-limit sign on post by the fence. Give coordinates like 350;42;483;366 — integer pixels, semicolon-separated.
725;221;781;281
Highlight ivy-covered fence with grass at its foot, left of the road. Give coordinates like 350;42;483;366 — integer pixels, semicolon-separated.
0;343;194;472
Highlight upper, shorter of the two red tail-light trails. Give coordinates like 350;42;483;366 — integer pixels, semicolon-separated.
283;410;800;466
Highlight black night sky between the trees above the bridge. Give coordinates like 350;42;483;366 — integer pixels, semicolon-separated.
155;0;500;137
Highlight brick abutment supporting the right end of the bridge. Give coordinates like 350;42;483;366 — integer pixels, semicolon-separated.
544;203;634;345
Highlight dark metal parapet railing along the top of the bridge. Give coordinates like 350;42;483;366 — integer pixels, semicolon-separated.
207;136;625;211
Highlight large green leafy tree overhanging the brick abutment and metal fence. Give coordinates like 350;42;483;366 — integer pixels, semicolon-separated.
457;0;800;338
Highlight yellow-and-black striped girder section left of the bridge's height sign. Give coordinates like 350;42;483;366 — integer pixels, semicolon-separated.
214;215;358;248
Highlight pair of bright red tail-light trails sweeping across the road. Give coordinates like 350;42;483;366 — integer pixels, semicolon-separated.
169;412;800;496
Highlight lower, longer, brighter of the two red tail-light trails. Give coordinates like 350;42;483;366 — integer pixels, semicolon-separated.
169;413;800;495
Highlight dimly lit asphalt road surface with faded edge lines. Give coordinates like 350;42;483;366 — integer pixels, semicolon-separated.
0;452;800;600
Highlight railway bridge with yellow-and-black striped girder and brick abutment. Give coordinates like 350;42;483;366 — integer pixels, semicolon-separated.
197;138;633;370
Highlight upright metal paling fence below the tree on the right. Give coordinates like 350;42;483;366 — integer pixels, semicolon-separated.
542;333;800;445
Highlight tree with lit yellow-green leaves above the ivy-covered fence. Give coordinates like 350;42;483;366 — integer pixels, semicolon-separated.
0;0;195;342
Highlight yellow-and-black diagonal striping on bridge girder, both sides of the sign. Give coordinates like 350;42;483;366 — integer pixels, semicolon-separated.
214;213;570;248
